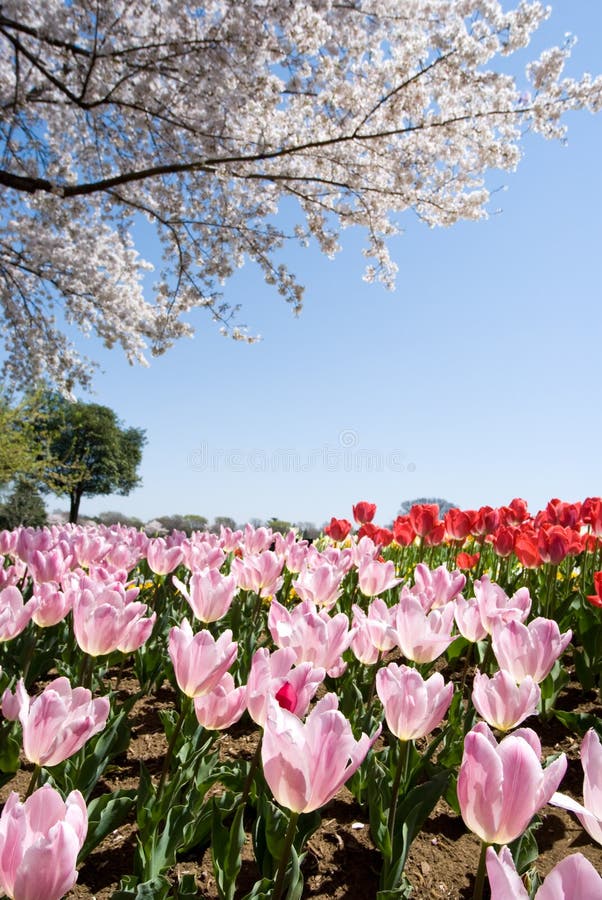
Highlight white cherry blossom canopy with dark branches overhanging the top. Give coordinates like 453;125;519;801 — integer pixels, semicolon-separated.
0;0;602;390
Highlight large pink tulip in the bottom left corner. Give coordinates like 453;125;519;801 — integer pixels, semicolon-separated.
0;784;88;900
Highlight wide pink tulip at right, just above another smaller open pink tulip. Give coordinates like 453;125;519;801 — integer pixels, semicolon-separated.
491;618;572;683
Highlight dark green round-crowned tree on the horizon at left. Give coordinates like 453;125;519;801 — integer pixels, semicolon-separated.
38;392;146;522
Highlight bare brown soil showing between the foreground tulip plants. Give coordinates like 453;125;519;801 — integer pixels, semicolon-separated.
0;681;602;900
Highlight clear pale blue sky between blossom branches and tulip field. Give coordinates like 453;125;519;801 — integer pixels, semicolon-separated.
38;0;602;525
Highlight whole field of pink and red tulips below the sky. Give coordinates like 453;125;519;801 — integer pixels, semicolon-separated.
0;498;602;900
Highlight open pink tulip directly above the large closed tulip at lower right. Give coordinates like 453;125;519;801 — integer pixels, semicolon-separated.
472;669;541;731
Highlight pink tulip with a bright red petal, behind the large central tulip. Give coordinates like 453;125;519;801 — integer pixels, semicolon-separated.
247;647;326;728
